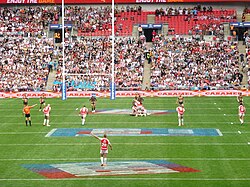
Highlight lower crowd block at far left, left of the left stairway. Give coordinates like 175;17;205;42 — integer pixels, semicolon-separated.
0;37;53;92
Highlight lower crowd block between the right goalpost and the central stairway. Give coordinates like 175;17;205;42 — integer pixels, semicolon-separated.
115;37;147;90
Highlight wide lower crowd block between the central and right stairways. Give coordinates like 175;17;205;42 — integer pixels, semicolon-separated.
151;37;243;90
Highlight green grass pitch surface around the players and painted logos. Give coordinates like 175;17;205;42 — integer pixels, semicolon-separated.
0;97;250;187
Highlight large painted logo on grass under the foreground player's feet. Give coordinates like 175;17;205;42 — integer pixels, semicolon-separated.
23;160;199;179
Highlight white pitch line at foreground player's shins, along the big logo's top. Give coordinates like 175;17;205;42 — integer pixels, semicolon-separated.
0;157;250;161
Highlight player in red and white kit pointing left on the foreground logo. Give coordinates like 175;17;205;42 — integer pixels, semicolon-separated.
91;133;112;166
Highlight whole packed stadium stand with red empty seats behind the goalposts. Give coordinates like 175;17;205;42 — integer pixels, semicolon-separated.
0;4;250;91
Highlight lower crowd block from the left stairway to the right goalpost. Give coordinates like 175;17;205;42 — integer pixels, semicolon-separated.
53;38;112;91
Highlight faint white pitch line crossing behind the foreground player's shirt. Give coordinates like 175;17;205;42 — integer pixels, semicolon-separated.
0;142;248;146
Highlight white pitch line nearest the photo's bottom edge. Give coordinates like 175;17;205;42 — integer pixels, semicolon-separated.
0;177;250;181
